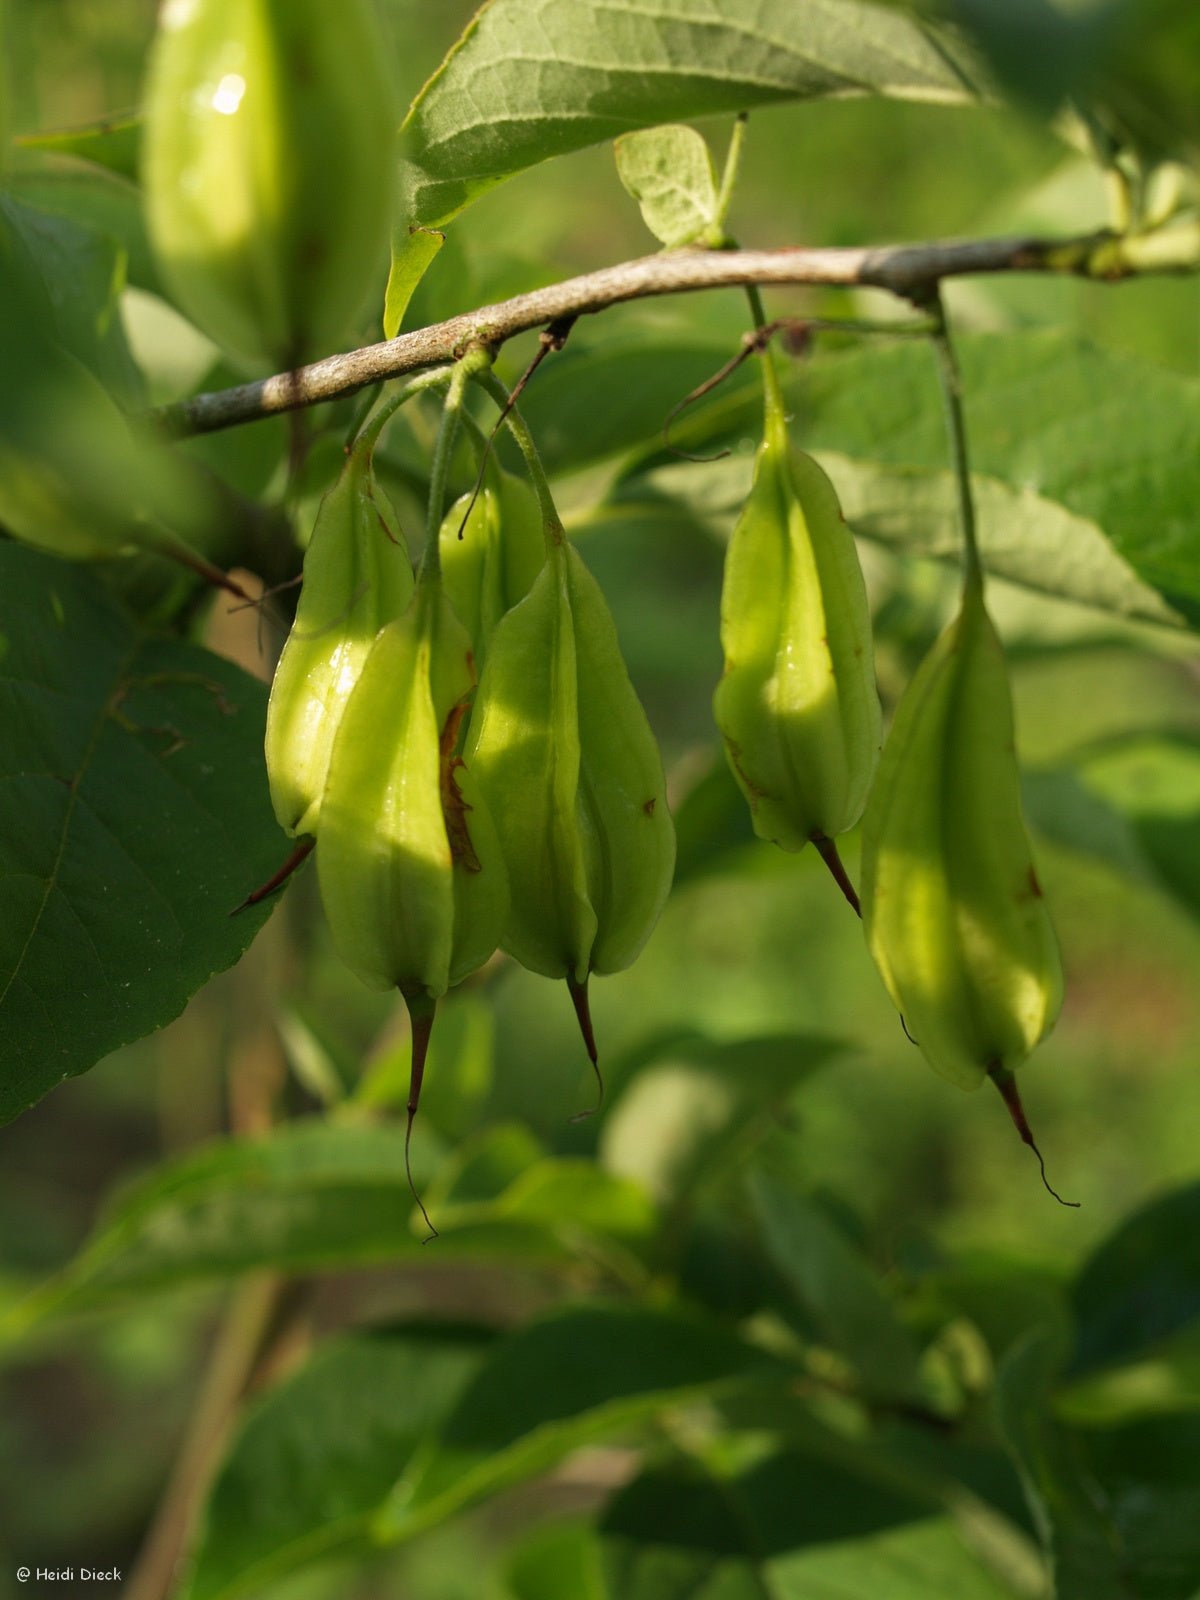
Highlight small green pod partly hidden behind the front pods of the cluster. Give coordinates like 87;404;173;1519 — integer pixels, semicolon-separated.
440;467;546;675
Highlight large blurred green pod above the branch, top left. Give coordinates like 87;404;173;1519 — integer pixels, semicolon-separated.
142;0;397;366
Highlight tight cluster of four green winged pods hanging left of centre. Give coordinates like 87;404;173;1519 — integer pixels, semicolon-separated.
257;352;675;1222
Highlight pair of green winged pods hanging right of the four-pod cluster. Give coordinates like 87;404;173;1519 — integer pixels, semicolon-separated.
714;324;1062;1192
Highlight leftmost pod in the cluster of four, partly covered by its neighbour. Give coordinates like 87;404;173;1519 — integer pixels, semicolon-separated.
266;440;413;834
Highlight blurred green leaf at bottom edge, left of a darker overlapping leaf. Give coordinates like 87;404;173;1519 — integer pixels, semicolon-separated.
184;1323;488;1600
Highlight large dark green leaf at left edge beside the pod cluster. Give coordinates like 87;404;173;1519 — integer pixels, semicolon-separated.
0;544;283;1122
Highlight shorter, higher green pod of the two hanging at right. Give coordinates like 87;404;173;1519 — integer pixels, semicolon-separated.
714;400;880;876
